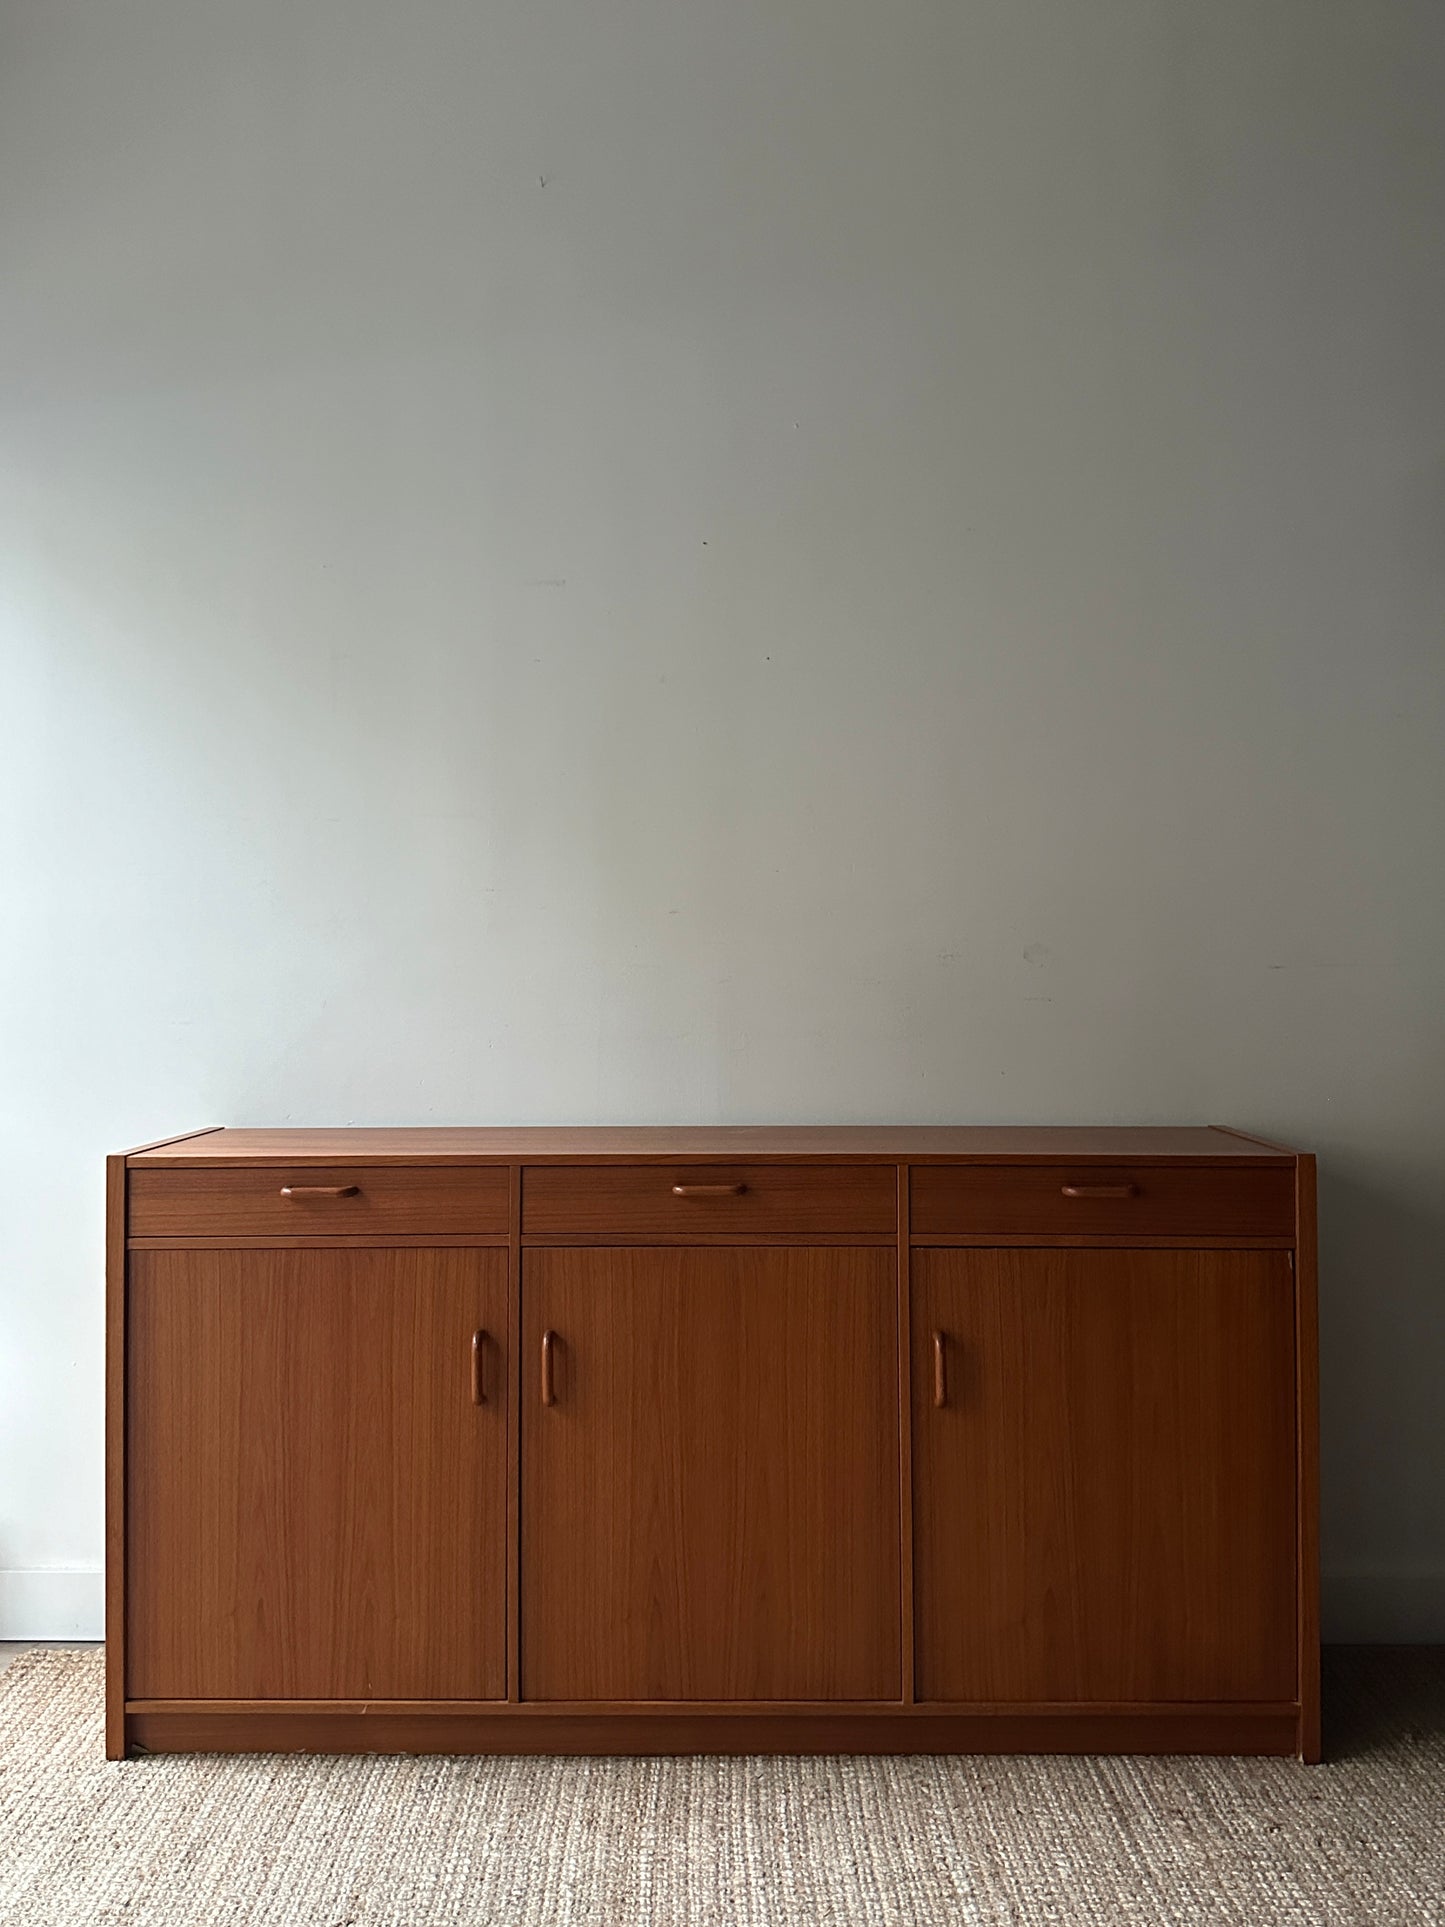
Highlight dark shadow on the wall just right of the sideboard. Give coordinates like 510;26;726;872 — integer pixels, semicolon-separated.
1320;1150;1445;1640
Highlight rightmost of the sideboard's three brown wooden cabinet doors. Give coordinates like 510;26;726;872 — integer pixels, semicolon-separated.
911;1251;1297;1702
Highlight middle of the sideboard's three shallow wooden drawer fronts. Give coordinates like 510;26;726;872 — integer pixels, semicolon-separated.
522;1164;898;1245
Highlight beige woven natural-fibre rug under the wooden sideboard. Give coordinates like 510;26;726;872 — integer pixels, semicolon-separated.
0;1651;1445;1927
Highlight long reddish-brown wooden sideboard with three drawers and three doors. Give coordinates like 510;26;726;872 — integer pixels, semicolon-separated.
106;1127;1320;1759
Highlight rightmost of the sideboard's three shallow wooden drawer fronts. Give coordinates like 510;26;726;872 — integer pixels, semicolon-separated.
909;1164;1295;1237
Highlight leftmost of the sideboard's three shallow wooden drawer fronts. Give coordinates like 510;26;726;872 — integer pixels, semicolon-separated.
129;1166;509;1237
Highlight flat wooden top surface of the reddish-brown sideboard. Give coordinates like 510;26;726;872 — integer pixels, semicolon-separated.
127;1123;1295;1170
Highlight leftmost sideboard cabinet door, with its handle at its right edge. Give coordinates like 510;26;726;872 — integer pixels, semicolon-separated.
125;1249;507;1700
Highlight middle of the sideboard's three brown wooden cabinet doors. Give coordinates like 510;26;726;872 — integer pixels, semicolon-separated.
522;1247;902;1700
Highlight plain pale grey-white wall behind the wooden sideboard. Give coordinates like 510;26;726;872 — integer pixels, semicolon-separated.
0;0;1445;1636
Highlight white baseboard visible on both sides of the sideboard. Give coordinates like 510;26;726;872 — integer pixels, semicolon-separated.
0;1567;1445;1646
